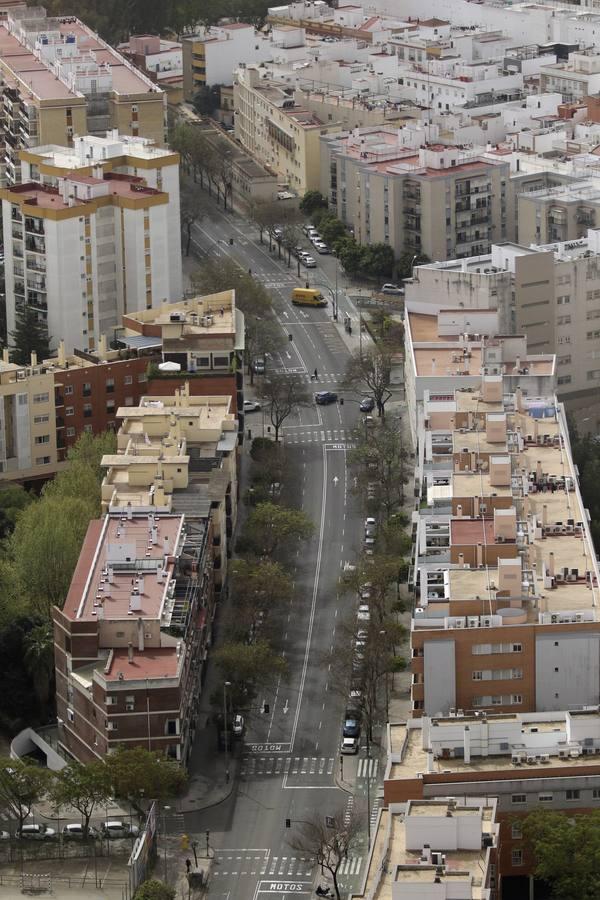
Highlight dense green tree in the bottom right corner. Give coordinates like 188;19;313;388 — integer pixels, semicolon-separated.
522;810;600;900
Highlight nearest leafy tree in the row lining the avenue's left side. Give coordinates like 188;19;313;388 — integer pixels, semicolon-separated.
211;639;288;710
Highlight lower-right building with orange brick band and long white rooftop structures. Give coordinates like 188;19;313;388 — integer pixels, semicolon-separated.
384;707;600;896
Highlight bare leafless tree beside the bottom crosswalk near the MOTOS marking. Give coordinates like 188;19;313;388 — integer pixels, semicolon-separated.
288;808;361;900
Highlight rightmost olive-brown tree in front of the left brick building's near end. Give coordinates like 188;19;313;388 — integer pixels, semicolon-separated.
105;746;187;816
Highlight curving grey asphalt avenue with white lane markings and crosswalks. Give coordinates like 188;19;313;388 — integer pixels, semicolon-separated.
186;202;375;900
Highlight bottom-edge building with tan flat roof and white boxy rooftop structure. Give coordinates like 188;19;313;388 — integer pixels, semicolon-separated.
350;795;500;900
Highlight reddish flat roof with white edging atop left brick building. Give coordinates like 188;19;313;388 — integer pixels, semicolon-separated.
64;510;183;621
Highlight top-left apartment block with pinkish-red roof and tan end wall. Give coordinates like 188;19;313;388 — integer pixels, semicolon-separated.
0;7;166;184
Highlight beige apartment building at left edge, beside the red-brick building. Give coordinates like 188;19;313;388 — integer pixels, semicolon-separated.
0;350;59;483
